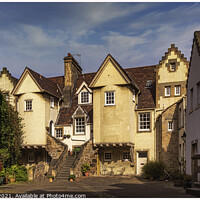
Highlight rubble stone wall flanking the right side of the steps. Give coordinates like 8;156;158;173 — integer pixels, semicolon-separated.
73;140;97;177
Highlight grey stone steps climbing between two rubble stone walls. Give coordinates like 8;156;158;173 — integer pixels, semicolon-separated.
56;154;75;180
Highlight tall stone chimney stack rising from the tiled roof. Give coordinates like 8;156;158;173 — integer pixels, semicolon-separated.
63;53;82;108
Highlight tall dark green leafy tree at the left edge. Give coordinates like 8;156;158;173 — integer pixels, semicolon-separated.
0;91;23;167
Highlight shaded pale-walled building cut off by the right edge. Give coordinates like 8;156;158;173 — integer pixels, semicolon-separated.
186;31;200;181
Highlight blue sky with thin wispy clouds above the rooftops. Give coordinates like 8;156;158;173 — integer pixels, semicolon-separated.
0;2;200;77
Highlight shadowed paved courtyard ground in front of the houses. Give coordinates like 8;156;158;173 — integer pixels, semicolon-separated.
0;176;195;198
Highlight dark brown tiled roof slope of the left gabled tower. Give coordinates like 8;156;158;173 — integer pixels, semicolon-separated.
27;67;62;98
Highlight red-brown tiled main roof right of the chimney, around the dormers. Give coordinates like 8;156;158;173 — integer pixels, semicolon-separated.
56;65;156;125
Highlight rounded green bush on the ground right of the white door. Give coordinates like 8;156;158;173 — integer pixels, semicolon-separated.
142;161;165;179
